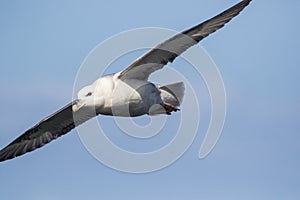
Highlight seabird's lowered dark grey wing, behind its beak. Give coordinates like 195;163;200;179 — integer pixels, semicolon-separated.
0;101;95;162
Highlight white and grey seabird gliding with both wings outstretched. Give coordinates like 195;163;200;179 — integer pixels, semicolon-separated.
0;0;251;162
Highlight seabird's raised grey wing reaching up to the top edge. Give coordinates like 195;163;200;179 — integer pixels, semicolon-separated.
119;0;251;80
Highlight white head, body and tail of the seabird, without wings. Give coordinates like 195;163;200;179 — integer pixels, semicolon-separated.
72;72;184;117
